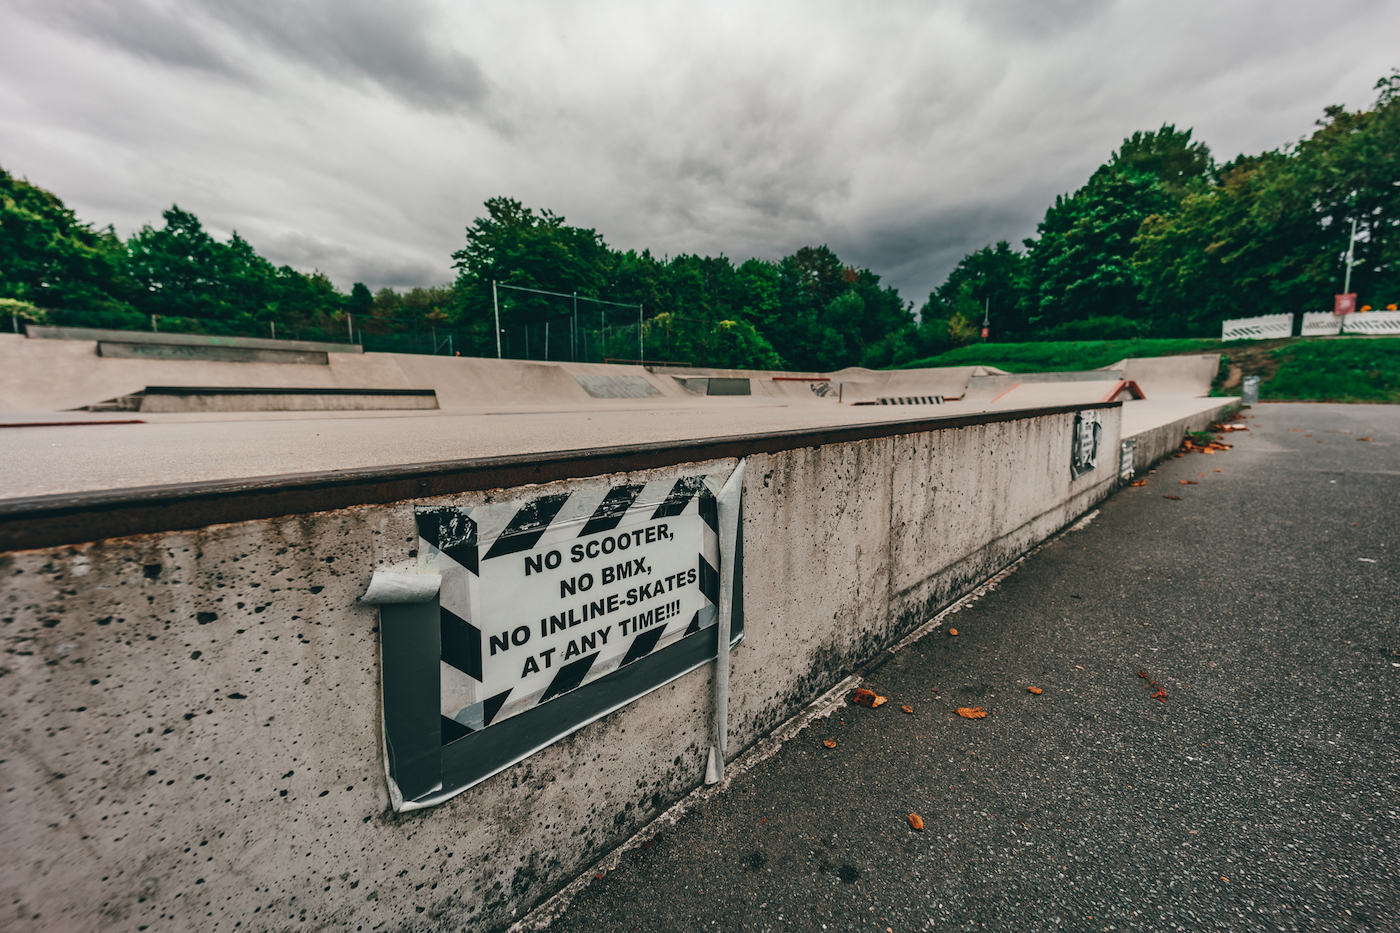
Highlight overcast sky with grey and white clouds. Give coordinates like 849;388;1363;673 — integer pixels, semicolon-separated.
0;0;1400;304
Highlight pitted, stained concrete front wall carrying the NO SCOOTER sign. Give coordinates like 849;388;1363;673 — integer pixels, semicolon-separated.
0;408;1121;930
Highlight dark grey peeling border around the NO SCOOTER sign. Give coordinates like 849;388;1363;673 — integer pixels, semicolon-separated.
365;471;743;811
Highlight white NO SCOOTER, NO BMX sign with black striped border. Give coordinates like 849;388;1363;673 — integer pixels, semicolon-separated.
416;475;724;744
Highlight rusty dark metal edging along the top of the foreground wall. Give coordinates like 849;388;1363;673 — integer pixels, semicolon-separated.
0;402;1123;551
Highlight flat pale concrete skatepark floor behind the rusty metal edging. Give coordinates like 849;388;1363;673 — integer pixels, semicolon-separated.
0;396;1225;497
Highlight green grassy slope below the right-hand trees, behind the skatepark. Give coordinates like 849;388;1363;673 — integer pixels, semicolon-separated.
900;338;1400;403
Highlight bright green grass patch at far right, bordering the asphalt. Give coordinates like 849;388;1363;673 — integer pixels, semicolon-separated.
1260;338;1400;403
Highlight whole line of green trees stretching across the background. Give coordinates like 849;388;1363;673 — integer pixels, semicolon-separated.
0;73;1400;371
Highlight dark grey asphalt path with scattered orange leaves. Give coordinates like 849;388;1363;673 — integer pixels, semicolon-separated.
534;405;1400;933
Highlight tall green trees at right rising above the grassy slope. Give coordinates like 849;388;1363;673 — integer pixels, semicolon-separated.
914;73;1400;341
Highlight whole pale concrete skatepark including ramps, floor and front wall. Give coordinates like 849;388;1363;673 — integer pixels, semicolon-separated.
0;323;1235;930
